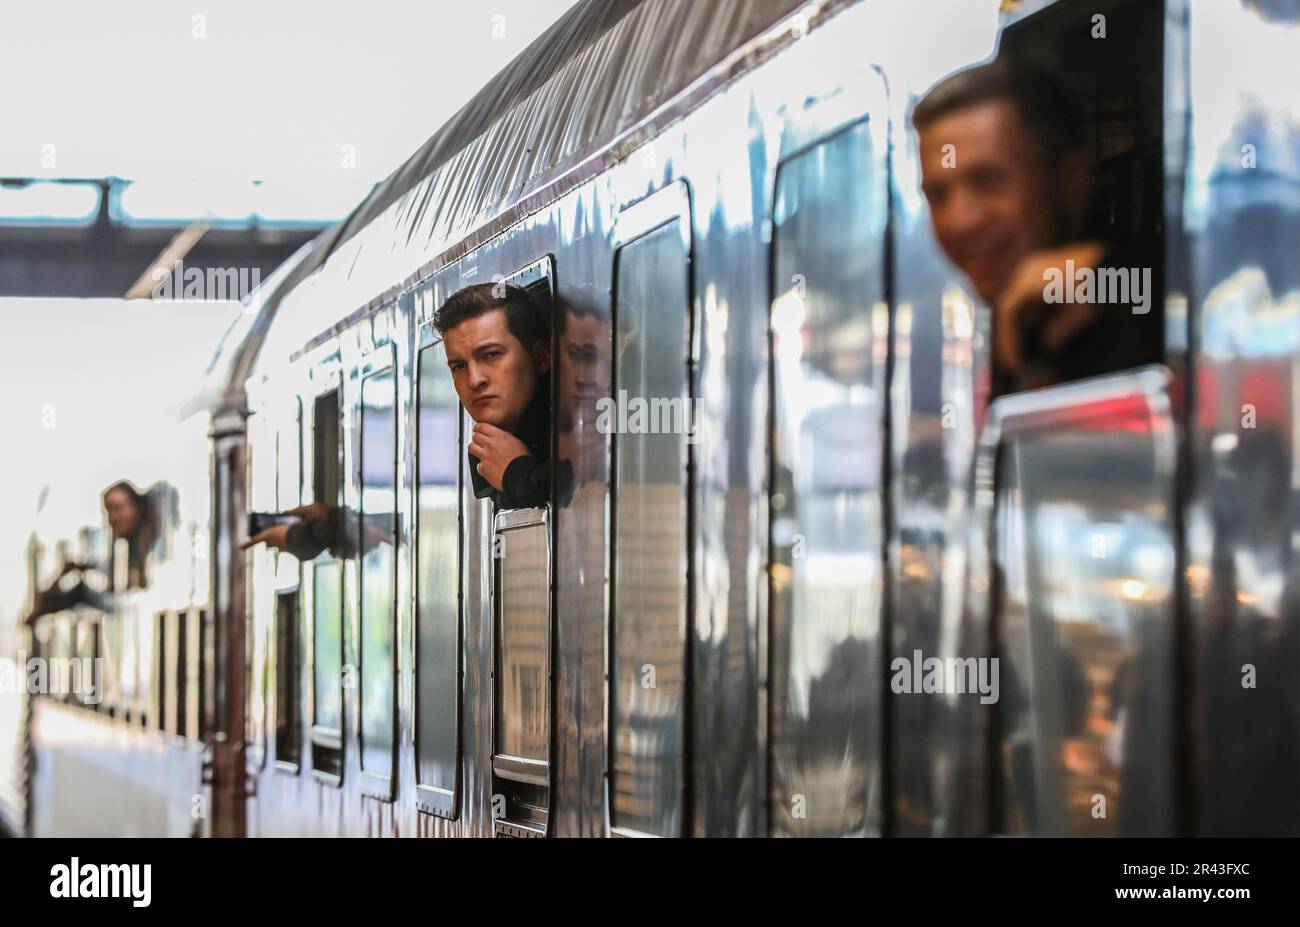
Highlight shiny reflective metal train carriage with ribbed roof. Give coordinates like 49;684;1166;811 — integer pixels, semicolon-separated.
10;0;1300;836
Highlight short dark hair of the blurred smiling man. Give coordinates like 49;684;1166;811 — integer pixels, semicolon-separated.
911;59;1087;159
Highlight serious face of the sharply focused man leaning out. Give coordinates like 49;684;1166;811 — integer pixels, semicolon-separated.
443;309;550;432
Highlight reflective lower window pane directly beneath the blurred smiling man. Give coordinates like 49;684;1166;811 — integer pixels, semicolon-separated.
982;369;1177;836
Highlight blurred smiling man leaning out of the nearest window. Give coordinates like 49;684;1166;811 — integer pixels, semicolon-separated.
913;60;1161;393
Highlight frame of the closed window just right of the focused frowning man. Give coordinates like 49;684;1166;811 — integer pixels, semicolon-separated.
603;178;701;837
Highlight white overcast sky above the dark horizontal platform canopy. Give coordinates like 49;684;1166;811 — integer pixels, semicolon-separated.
0;0;573;215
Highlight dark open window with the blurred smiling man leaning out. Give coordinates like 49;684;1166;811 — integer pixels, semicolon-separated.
913;0;1173;397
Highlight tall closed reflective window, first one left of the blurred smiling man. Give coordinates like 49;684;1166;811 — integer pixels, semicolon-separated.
768;120;888;836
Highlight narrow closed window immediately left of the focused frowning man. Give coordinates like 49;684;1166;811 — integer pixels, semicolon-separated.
416;342;463;816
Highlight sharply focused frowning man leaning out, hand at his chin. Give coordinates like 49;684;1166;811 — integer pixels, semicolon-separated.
433;283;551;508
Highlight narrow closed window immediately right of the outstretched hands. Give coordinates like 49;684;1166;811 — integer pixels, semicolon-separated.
358;358;398;797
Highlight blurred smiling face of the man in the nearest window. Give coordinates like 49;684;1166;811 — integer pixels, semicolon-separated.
919;101;1062;303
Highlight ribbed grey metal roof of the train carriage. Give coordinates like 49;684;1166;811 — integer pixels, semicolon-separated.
187;0;805;412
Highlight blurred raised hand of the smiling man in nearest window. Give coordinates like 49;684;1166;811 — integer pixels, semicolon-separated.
993;242;1105;373
